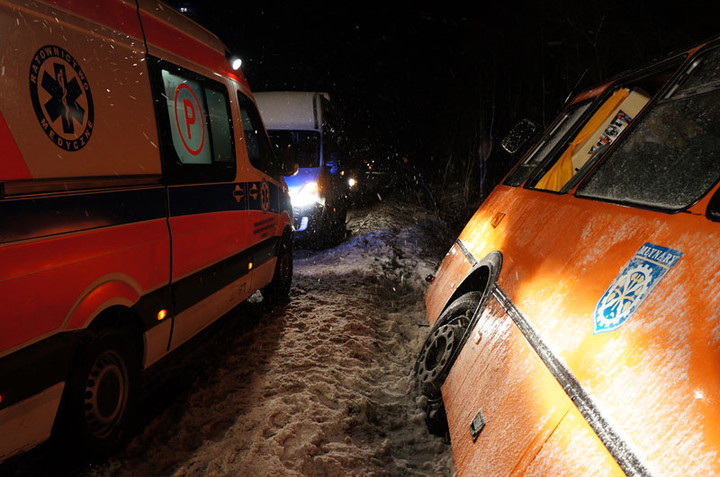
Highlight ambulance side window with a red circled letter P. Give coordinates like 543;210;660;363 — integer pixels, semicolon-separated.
151;60;235;183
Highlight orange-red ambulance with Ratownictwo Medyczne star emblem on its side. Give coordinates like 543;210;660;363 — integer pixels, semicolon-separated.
0;0;294;459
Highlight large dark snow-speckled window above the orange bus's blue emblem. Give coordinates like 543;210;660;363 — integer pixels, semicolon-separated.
577;49;720;210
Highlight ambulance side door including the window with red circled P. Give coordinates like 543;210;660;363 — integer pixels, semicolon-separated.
146;59;251;348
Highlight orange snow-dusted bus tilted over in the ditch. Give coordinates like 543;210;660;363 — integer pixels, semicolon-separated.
416;40;720;476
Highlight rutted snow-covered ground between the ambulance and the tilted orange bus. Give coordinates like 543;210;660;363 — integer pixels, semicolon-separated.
8;195;454;477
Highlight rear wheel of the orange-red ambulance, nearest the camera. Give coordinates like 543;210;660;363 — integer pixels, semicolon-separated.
54;329;140;456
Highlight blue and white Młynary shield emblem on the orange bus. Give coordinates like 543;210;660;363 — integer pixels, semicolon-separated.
593;243;683;334
